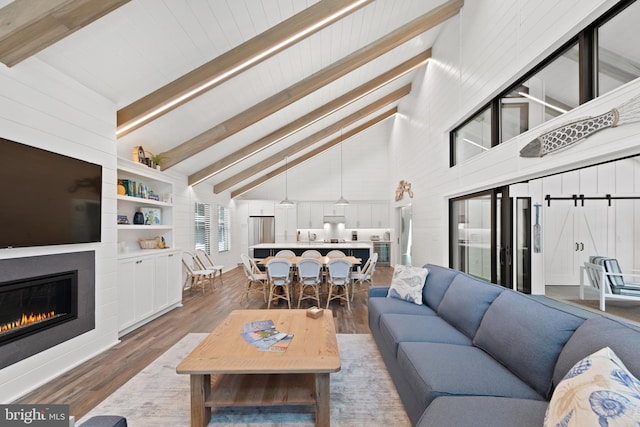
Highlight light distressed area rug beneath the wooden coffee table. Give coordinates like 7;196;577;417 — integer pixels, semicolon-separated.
77;333;411;427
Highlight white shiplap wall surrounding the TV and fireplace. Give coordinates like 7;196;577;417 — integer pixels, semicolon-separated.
0;58;118;403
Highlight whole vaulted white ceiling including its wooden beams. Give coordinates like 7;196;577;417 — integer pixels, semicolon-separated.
0;0;463;196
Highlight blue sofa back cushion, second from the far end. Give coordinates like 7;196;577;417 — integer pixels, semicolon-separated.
438;274;504;338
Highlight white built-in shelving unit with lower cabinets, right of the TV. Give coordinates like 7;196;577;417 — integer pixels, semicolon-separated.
117;159;182;336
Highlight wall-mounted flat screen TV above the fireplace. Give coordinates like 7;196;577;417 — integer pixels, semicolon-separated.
0;138;102;248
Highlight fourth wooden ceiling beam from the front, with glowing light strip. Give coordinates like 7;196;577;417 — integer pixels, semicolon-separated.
188;49;431;185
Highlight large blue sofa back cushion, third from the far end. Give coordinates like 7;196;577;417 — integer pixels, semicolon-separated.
473;290;584;396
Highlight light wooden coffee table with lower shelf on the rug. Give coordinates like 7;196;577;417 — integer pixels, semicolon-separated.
176;310;340;427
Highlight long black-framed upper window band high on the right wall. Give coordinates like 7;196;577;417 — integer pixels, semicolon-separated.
450;0;640;166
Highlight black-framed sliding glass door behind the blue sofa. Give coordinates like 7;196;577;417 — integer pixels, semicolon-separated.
449;187;512;287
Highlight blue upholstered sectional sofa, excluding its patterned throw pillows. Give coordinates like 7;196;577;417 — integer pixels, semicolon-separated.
368;264;640;427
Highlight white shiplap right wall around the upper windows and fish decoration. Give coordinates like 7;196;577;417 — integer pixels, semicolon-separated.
389;0;640;286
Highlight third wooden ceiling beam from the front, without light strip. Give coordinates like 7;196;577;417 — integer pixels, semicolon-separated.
162;0;464;169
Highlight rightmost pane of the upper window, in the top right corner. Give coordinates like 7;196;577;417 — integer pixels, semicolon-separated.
598;1;640;95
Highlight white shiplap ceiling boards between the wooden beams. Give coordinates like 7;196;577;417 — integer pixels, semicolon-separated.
22;0;458;195
